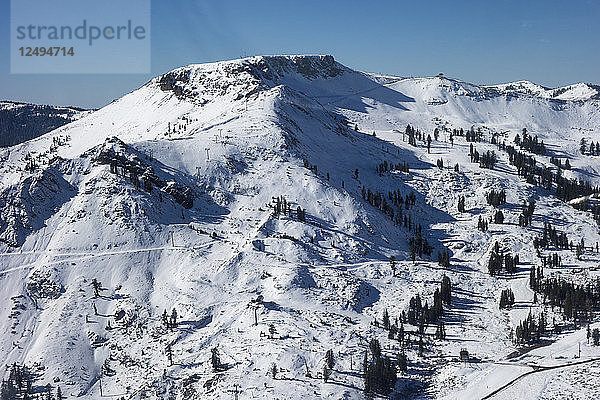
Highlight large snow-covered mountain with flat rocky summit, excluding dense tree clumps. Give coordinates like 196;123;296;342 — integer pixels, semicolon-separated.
0;56;600;399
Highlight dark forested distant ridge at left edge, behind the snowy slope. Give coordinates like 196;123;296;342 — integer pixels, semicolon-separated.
0;101;87;147
